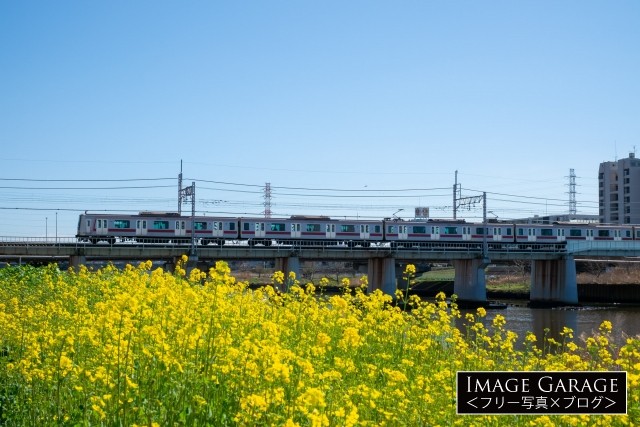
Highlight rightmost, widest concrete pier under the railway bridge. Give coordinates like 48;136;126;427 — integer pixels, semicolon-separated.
530;255;578;305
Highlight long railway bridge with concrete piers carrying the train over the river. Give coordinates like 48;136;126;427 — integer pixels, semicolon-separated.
0;238;640;305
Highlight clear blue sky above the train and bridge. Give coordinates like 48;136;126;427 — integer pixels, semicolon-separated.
0;0;640;237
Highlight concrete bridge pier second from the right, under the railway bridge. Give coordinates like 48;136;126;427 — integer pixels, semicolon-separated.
451;258;489;303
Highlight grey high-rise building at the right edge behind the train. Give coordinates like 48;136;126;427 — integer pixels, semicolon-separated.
598;153;640;224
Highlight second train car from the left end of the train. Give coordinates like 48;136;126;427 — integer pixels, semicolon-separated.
240;216;383;247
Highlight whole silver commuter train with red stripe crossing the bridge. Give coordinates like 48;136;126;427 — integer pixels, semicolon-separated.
76;211;640;247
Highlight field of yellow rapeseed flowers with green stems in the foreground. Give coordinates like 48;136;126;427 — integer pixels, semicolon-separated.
0;259;640;426
